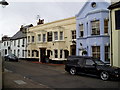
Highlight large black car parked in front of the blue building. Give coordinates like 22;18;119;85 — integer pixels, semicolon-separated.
65;56;120;80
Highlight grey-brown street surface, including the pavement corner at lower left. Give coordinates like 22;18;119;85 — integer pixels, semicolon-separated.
3;60;120;89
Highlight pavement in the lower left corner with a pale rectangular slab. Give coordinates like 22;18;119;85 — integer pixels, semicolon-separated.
3;69;52;89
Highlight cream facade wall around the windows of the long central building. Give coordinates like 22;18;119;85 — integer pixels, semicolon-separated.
27;17;76;61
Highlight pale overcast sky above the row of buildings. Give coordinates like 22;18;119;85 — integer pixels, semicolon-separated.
0;0;109;39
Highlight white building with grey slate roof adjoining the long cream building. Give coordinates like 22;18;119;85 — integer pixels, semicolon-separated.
10;24;33;59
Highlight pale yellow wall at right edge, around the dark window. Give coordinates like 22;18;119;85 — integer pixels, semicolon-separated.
111;8;120;67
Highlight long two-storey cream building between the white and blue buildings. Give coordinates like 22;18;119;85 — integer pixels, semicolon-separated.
27;17;76;62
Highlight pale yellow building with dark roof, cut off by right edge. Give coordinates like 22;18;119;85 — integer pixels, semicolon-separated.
109;2;120;67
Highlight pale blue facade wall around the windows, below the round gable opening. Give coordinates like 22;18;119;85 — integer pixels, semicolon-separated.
76;1;110;62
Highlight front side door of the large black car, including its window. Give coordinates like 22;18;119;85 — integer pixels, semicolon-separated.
84;59;96;74
